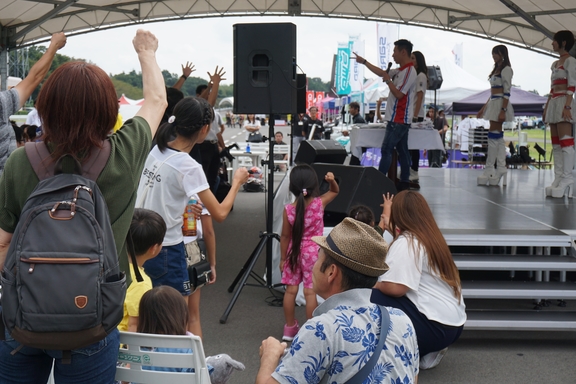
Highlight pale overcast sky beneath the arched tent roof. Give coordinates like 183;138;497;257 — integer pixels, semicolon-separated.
61;16;554;95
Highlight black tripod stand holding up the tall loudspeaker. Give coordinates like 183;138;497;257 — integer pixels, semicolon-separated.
220;118;282;324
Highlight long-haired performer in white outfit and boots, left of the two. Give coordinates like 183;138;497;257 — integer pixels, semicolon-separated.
478;45;514;185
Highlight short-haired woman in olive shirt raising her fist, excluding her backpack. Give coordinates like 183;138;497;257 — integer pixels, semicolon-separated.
0;30;166;384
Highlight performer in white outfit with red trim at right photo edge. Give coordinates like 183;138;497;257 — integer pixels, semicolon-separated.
543;31;576;198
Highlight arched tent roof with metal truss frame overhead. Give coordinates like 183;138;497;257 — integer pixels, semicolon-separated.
0;0;576;54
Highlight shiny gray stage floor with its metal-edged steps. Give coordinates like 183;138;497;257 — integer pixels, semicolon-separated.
419;168;576;331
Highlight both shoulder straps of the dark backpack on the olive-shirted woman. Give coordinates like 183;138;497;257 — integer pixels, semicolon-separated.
24;140;112;181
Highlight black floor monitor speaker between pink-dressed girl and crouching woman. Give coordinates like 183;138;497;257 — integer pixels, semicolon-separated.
312;163;396;227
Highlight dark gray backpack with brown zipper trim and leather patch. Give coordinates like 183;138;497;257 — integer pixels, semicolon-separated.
2;140;126;351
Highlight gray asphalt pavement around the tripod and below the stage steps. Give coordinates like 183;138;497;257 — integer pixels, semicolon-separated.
201;127;576;384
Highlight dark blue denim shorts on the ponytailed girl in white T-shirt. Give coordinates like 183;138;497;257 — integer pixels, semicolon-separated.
144;242;192;296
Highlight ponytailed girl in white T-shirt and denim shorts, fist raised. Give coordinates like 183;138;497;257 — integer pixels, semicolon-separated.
136;97;248;340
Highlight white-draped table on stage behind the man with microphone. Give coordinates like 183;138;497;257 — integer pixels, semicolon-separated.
350;124;445;159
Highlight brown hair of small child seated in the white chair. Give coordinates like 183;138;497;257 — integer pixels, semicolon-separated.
136;285;188;335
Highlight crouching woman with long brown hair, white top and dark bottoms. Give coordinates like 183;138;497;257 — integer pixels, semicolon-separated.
371;191;466;369
